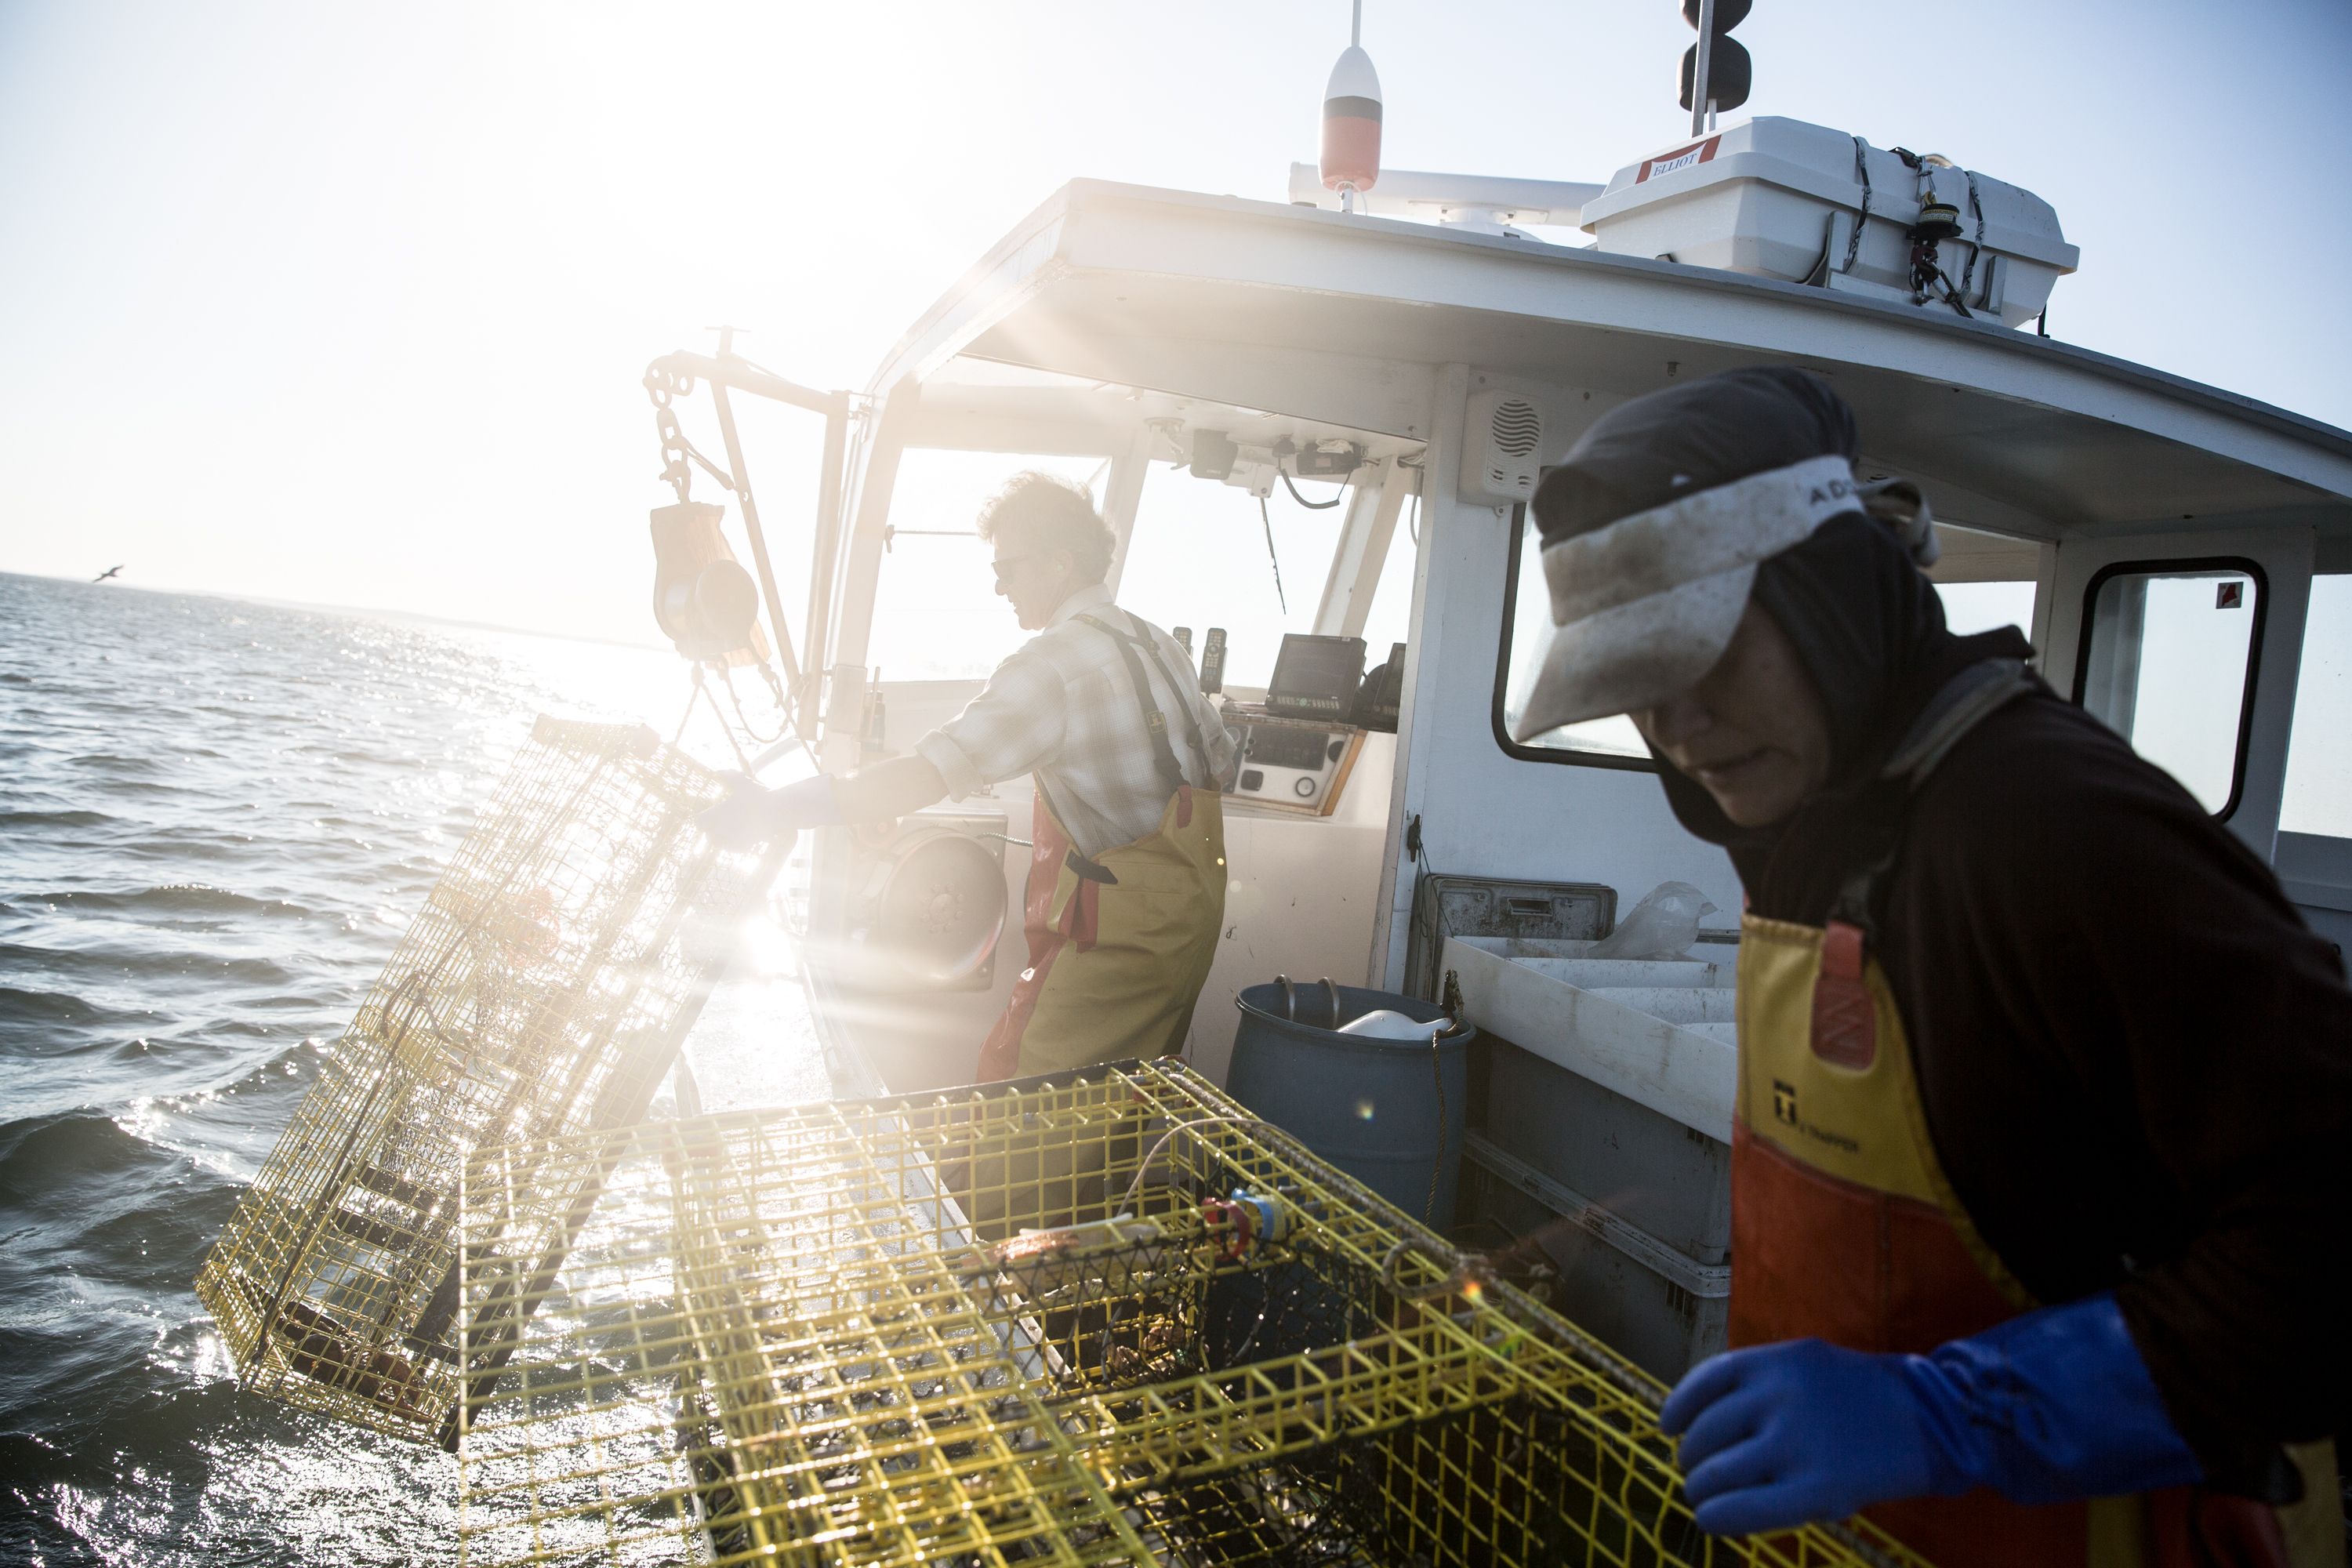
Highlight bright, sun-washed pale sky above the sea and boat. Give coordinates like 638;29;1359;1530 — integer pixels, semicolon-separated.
0;0;2352;642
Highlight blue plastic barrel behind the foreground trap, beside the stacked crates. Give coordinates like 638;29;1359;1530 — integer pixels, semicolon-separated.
1225;982;1477;1232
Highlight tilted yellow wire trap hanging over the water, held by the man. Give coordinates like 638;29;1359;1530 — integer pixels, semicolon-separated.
195;717;769;1441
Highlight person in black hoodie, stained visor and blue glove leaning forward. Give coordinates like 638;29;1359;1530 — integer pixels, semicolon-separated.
1515;367;2352;1568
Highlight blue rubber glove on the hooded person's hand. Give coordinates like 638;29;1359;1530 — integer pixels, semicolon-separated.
1658;1295;2204;1535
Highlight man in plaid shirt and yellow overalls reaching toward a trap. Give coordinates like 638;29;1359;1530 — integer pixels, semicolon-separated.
710;473;1235;1079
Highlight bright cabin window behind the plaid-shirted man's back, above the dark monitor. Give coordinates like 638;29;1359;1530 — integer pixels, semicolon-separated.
1120;468;1355;689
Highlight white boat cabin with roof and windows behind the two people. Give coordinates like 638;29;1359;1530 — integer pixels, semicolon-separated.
670;159;2352;1377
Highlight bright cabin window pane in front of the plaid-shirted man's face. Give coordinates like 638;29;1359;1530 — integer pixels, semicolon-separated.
866;447;1110;682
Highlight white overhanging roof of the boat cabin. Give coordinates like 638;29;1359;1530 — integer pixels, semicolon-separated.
870;181;2352;572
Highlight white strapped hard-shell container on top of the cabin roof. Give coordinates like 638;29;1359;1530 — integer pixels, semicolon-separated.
1583;118;2082;327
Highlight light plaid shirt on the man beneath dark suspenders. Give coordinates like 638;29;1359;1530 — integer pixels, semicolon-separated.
915;586;1235;858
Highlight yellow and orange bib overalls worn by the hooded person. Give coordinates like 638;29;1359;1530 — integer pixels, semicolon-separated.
1731;916;2345;1568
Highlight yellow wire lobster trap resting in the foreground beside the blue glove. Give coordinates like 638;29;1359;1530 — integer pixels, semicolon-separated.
459;1062;1915;1568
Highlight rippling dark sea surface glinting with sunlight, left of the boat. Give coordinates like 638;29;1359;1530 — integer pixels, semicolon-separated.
0;576;823;1568
